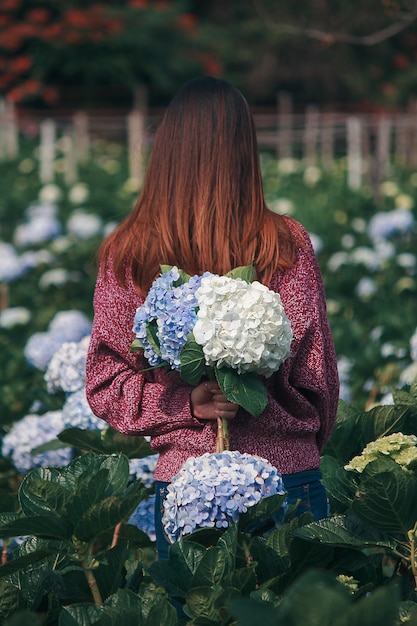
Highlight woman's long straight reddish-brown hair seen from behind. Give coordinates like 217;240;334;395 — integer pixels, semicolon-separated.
100;77;295;295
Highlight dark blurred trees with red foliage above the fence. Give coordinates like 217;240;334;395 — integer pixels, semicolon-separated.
0;0;417;111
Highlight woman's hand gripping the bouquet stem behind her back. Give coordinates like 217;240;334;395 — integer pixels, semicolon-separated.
190;380;239;420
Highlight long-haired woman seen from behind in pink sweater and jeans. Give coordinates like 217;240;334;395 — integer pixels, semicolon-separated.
87;77;339;558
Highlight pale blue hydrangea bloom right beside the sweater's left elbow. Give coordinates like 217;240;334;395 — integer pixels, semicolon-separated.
44;335;90;394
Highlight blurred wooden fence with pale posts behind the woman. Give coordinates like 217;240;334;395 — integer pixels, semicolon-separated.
0;97;417;189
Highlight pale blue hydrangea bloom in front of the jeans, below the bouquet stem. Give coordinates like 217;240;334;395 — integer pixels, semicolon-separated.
162;451;285;542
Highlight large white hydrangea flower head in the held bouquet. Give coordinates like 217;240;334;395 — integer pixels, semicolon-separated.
193;275;293;377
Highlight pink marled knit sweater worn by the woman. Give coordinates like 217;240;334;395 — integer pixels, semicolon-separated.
86;221;339;481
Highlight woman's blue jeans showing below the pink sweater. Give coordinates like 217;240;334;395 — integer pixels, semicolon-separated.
155;469;329;561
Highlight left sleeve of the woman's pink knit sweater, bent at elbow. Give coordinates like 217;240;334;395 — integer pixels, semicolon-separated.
86;264;206;437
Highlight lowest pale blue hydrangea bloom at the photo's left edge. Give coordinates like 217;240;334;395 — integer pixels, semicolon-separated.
1;411;72;474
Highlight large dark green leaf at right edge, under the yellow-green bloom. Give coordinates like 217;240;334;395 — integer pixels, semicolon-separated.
352;458;417;536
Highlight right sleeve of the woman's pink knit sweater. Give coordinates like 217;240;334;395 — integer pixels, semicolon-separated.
267;224;339;451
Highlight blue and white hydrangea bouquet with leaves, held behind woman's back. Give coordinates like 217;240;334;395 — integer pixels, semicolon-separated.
131;266;293;417
